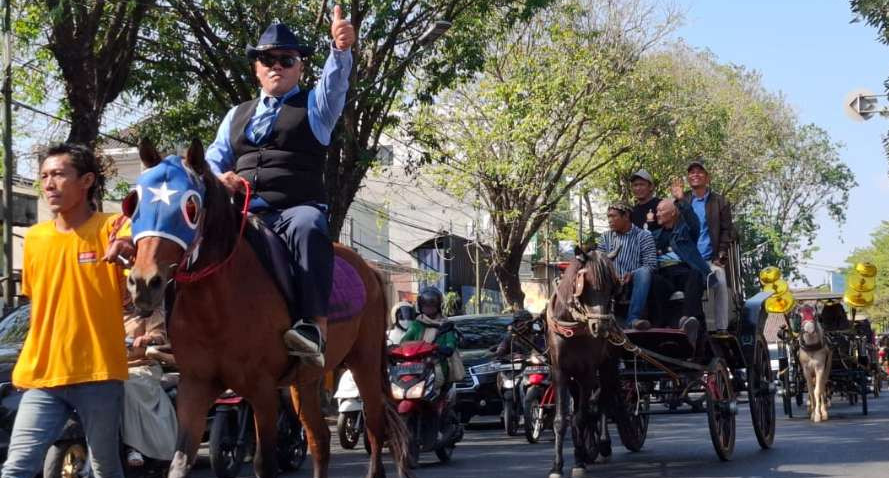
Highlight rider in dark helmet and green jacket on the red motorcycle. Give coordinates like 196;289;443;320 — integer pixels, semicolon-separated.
400;286;459;400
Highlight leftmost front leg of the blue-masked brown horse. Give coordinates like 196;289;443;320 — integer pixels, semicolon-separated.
168;376;222;478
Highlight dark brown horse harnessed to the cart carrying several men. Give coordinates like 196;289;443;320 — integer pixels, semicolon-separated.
546;251;623;478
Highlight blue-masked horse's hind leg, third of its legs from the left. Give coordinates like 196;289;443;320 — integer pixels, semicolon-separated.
290;379;332;478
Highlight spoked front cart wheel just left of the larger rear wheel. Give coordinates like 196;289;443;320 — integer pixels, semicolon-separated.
705;357;737;461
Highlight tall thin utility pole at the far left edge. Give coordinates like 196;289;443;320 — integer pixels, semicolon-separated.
3;0;15;307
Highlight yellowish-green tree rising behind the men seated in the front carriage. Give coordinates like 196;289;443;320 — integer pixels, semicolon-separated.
590;43;856;293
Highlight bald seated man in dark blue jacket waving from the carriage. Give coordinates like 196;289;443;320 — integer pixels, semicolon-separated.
652;199;712;344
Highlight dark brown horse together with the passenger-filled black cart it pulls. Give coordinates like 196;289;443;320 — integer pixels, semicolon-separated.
548;248;775;478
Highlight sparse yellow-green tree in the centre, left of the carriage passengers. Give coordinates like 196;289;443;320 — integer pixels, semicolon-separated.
409;1;671;309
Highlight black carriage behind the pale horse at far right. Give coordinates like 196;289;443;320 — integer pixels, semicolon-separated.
778;291;882;417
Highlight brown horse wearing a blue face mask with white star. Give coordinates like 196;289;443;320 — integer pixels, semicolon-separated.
125;141;410;478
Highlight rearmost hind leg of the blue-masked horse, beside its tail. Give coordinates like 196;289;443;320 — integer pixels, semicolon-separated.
347;362;386;478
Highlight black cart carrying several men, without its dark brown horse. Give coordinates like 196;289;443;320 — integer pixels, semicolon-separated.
615;246;775;460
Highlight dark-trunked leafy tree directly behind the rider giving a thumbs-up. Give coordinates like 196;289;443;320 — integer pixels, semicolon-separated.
130;0;551;237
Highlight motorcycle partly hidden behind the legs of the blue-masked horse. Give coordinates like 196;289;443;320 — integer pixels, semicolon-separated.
208;389;308;478
